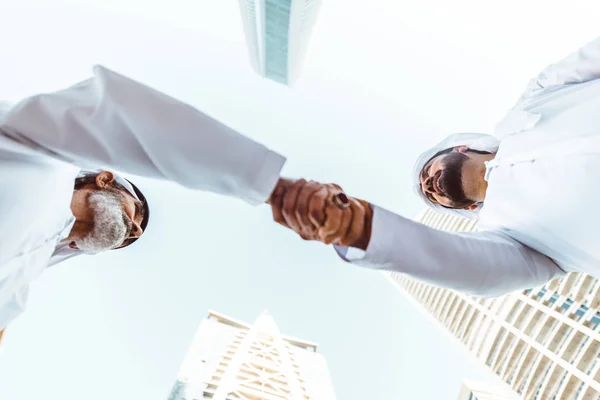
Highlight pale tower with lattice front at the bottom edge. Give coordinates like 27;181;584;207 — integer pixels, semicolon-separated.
168;311;335;400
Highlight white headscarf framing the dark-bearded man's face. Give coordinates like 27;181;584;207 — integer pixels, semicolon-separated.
413;133;500;219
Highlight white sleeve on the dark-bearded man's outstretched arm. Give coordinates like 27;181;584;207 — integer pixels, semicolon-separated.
336;207;564;297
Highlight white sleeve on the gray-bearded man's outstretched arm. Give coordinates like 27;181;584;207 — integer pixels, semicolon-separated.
0;66;285;204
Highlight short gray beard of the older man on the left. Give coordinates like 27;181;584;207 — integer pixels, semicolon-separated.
76;191;131;254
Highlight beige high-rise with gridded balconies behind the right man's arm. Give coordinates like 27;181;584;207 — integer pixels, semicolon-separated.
386;209;600;400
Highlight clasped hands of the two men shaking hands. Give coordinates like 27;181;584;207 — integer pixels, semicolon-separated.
267;178;373;250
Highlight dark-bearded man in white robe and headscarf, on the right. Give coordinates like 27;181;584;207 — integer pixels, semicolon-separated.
274;38;600;296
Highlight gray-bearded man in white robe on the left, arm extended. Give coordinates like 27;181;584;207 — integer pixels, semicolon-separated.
0;67;289;331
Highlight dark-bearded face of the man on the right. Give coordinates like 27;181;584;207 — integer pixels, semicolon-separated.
419;147;479;209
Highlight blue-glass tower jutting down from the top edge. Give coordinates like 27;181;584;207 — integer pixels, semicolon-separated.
239;0;321;86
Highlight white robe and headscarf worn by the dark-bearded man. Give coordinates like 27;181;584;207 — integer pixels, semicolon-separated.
338;38;600;297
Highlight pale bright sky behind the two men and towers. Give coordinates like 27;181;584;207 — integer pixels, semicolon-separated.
0;0;600;400
